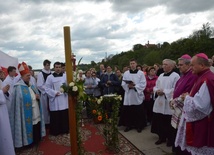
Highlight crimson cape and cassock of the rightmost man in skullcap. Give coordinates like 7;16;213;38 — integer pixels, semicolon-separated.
186;69;214;148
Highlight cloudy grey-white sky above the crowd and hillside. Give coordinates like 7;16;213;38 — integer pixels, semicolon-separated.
0;0;214;69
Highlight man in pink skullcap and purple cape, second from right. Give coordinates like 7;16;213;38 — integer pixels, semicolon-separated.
170;54;197;155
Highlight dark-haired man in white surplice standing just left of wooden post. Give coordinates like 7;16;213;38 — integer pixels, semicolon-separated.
45;62;69;135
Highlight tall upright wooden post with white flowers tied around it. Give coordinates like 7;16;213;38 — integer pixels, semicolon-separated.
64;26;78;155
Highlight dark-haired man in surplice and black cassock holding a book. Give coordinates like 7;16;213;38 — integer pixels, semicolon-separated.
119;59;146;132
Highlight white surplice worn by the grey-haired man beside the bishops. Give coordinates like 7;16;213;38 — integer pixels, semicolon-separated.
153;72;180;115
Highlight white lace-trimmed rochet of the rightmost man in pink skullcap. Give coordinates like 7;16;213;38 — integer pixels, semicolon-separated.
175;83;214;155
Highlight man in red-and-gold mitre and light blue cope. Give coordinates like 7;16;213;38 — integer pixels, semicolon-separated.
9;62;46;148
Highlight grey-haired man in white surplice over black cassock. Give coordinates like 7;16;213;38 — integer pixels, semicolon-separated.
151;59;180;146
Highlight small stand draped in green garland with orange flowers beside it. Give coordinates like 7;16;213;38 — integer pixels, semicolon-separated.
88;94;122;152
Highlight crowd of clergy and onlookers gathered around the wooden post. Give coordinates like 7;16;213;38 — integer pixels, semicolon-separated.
0;53;214;155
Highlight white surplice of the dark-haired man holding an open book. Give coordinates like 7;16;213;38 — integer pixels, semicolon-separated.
121;70;146;105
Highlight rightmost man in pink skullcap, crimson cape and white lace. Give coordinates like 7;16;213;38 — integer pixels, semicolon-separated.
175;53;214;155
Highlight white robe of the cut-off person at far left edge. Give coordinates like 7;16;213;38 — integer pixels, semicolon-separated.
0;90;15;155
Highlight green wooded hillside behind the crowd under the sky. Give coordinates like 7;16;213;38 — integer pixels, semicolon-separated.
79;23;214;70
